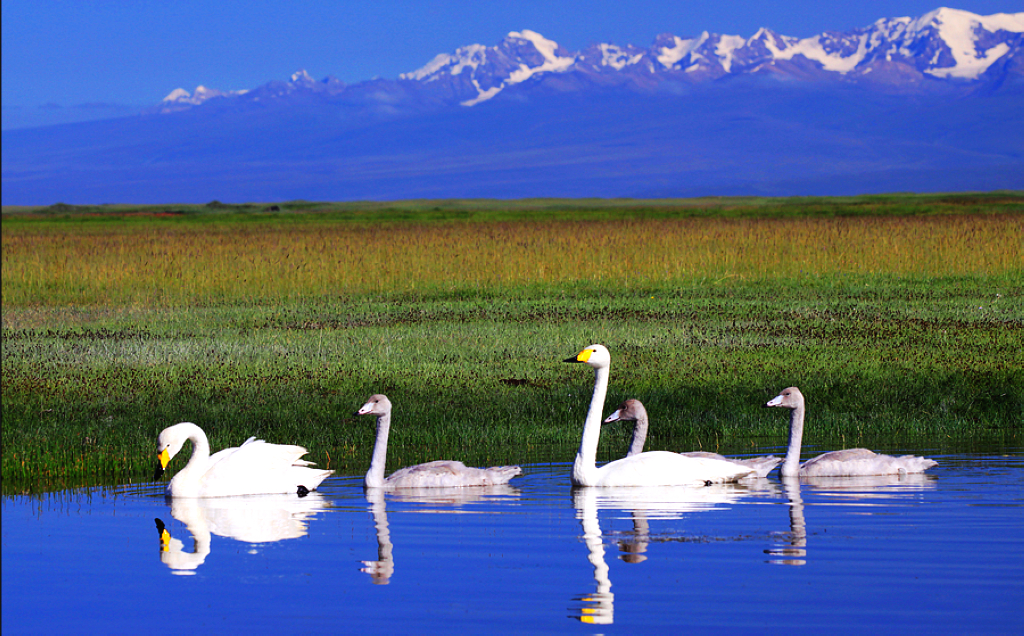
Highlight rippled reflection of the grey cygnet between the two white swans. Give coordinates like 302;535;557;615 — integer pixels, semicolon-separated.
359;483;519;585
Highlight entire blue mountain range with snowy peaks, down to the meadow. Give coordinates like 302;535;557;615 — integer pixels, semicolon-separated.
2;9;1024;205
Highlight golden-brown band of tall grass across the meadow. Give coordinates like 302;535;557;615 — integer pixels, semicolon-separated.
2;214;1024;305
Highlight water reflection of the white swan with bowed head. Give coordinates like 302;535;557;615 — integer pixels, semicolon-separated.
156;493;329;575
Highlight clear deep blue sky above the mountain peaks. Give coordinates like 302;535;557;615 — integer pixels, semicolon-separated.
2;0;1022;113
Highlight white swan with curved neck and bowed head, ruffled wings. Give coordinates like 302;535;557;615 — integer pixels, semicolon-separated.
154;422;334;497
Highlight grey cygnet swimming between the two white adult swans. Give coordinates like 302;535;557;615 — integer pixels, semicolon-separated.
355;394;522;489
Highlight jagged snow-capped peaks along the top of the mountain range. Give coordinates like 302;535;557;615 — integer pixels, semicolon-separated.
157;8;1024;112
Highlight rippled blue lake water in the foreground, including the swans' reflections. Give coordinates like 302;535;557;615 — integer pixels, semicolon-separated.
2;450;1024;635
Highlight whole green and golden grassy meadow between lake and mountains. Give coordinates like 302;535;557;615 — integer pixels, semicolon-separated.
2;194;1024;489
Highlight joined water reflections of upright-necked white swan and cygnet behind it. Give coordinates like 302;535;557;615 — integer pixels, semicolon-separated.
569;483;752;625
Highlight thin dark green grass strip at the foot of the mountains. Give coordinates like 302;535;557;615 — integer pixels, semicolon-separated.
3;190;1024;223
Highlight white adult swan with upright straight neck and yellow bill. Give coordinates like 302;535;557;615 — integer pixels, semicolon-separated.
564;344;754;486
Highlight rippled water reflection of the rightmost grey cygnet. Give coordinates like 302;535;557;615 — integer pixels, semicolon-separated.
765;473;936;565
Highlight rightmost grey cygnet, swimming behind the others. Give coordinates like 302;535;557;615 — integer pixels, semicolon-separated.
765;386;938;477
